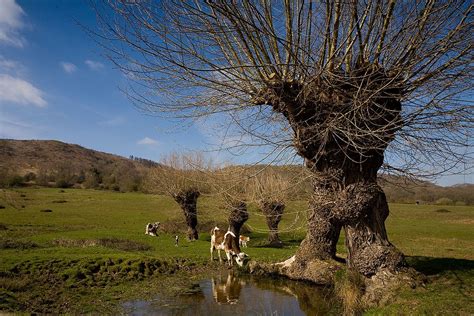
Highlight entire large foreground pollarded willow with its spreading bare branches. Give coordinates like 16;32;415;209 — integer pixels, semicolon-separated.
98;0;473;279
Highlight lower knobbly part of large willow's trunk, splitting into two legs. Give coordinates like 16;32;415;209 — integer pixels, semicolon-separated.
296;157;406;277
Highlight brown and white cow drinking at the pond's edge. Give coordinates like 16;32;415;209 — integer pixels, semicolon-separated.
211;227;248;267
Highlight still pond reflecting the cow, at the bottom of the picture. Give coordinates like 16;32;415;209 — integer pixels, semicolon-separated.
122;271;341;316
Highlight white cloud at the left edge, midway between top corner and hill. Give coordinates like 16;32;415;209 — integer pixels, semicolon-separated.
0;74;47;107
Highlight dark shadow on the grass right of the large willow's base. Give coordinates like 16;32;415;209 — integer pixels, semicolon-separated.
407;256;474;275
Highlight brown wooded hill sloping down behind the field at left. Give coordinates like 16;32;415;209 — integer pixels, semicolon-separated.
0;139;159;191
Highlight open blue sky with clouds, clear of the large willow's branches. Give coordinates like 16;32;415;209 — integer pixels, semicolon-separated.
0;0;474;185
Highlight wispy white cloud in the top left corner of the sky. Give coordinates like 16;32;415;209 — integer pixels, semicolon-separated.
0;0;26;47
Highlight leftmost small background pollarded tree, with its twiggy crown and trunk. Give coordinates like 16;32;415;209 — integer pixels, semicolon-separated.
147;153;211;241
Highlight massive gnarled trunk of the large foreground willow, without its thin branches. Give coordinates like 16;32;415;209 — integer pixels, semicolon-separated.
254;66;405;283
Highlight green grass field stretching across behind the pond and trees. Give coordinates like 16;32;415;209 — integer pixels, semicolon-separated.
0;189;474;314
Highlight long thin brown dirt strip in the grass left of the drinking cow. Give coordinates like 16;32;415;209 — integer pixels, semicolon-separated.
53;238;153;251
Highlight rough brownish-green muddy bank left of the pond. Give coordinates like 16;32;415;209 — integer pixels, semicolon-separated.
0;258;211;314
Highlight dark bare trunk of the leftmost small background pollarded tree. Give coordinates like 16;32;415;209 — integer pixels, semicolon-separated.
173;189;200;241
